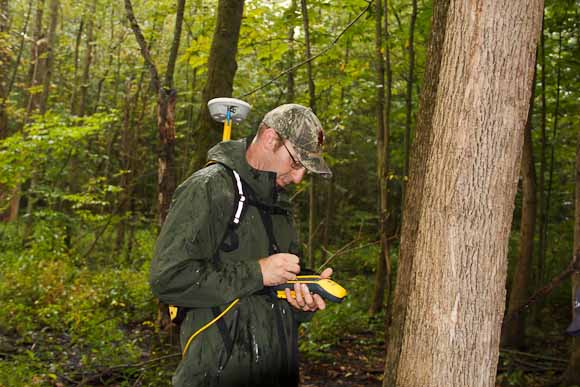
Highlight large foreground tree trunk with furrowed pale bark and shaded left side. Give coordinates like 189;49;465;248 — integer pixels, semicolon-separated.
384;0;543;387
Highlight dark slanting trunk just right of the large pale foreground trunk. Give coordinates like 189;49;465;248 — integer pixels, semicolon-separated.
502;69;538;349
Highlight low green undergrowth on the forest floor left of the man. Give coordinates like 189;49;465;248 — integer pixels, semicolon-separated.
0;223;172;387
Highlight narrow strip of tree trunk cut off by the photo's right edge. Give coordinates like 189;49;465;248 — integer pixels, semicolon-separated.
564;109;580;385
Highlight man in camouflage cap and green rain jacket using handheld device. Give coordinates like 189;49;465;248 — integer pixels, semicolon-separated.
150;104;332;387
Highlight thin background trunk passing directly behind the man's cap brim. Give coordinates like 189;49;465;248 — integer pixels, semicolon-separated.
300;0;316;268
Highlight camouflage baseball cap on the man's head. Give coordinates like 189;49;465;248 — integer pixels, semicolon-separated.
262;103;332;178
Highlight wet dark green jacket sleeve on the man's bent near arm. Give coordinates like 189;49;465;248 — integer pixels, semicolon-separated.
150;173;263;308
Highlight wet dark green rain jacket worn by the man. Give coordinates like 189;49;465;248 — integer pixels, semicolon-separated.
150;138;312;387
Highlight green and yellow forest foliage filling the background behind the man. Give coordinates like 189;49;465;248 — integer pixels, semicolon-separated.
0;0;580;386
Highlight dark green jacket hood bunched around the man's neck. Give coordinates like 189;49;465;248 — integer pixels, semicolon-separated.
207;136;290;209
